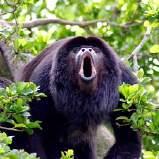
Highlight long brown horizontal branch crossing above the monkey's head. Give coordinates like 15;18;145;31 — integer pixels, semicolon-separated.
0;19;141;28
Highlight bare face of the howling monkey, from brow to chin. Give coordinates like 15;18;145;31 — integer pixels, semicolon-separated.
70;46;103;93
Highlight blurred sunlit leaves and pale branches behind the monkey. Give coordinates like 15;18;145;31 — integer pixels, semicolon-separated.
0;0;159;159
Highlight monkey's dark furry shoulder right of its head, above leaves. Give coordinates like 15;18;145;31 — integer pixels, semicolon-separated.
119;61;138;85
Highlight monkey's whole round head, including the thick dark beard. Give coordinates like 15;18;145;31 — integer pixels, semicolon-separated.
50;37;120;116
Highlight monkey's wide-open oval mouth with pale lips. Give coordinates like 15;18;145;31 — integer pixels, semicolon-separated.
79;55;96;81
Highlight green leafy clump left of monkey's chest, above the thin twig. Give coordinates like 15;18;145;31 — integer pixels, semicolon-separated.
0;82;44;133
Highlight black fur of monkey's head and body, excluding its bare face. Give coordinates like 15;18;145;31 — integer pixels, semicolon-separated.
16;37;141;159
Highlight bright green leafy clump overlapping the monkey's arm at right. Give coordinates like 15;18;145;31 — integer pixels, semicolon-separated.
115;70;159;158
